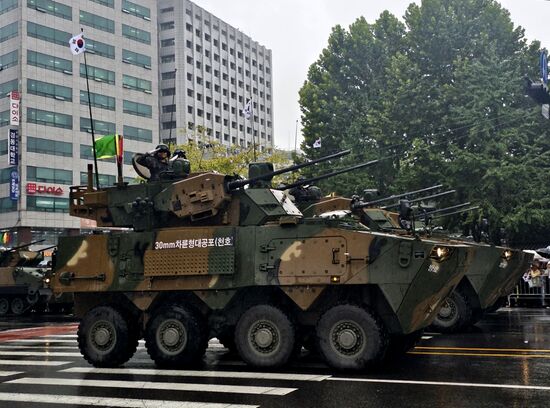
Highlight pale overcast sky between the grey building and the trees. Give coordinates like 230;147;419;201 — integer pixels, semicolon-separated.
193;0;550;149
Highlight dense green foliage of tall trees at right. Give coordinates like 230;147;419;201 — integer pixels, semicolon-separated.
300;0;550;243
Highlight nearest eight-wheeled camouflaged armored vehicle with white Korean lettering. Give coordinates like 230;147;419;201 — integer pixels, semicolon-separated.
53;152;468;369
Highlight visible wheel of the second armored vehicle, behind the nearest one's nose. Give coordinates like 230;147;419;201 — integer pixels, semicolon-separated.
431;290;472;333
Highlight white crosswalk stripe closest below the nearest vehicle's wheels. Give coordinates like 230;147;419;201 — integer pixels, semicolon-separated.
61;367;331;381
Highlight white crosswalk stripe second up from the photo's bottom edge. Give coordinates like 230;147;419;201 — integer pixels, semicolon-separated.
4;377;297;395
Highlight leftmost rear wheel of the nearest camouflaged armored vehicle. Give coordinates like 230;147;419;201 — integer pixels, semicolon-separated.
78;306;137;367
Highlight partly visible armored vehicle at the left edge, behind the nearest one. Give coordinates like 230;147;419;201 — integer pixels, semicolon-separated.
0;244;51;316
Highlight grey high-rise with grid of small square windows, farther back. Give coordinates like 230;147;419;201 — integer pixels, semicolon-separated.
158;0;273;149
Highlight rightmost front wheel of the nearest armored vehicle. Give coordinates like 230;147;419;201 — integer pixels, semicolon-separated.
316;305;388;370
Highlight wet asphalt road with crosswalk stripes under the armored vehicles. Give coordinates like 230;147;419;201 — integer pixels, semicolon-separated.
0;308;550;408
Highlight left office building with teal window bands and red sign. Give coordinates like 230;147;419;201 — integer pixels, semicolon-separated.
0;0;159;244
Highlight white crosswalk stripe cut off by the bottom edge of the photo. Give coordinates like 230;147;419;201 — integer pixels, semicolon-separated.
0;392;258;408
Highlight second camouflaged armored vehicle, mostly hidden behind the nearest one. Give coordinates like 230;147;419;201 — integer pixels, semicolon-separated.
303;193;531;332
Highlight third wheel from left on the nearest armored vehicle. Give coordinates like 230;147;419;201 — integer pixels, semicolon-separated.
235;305;296;367
